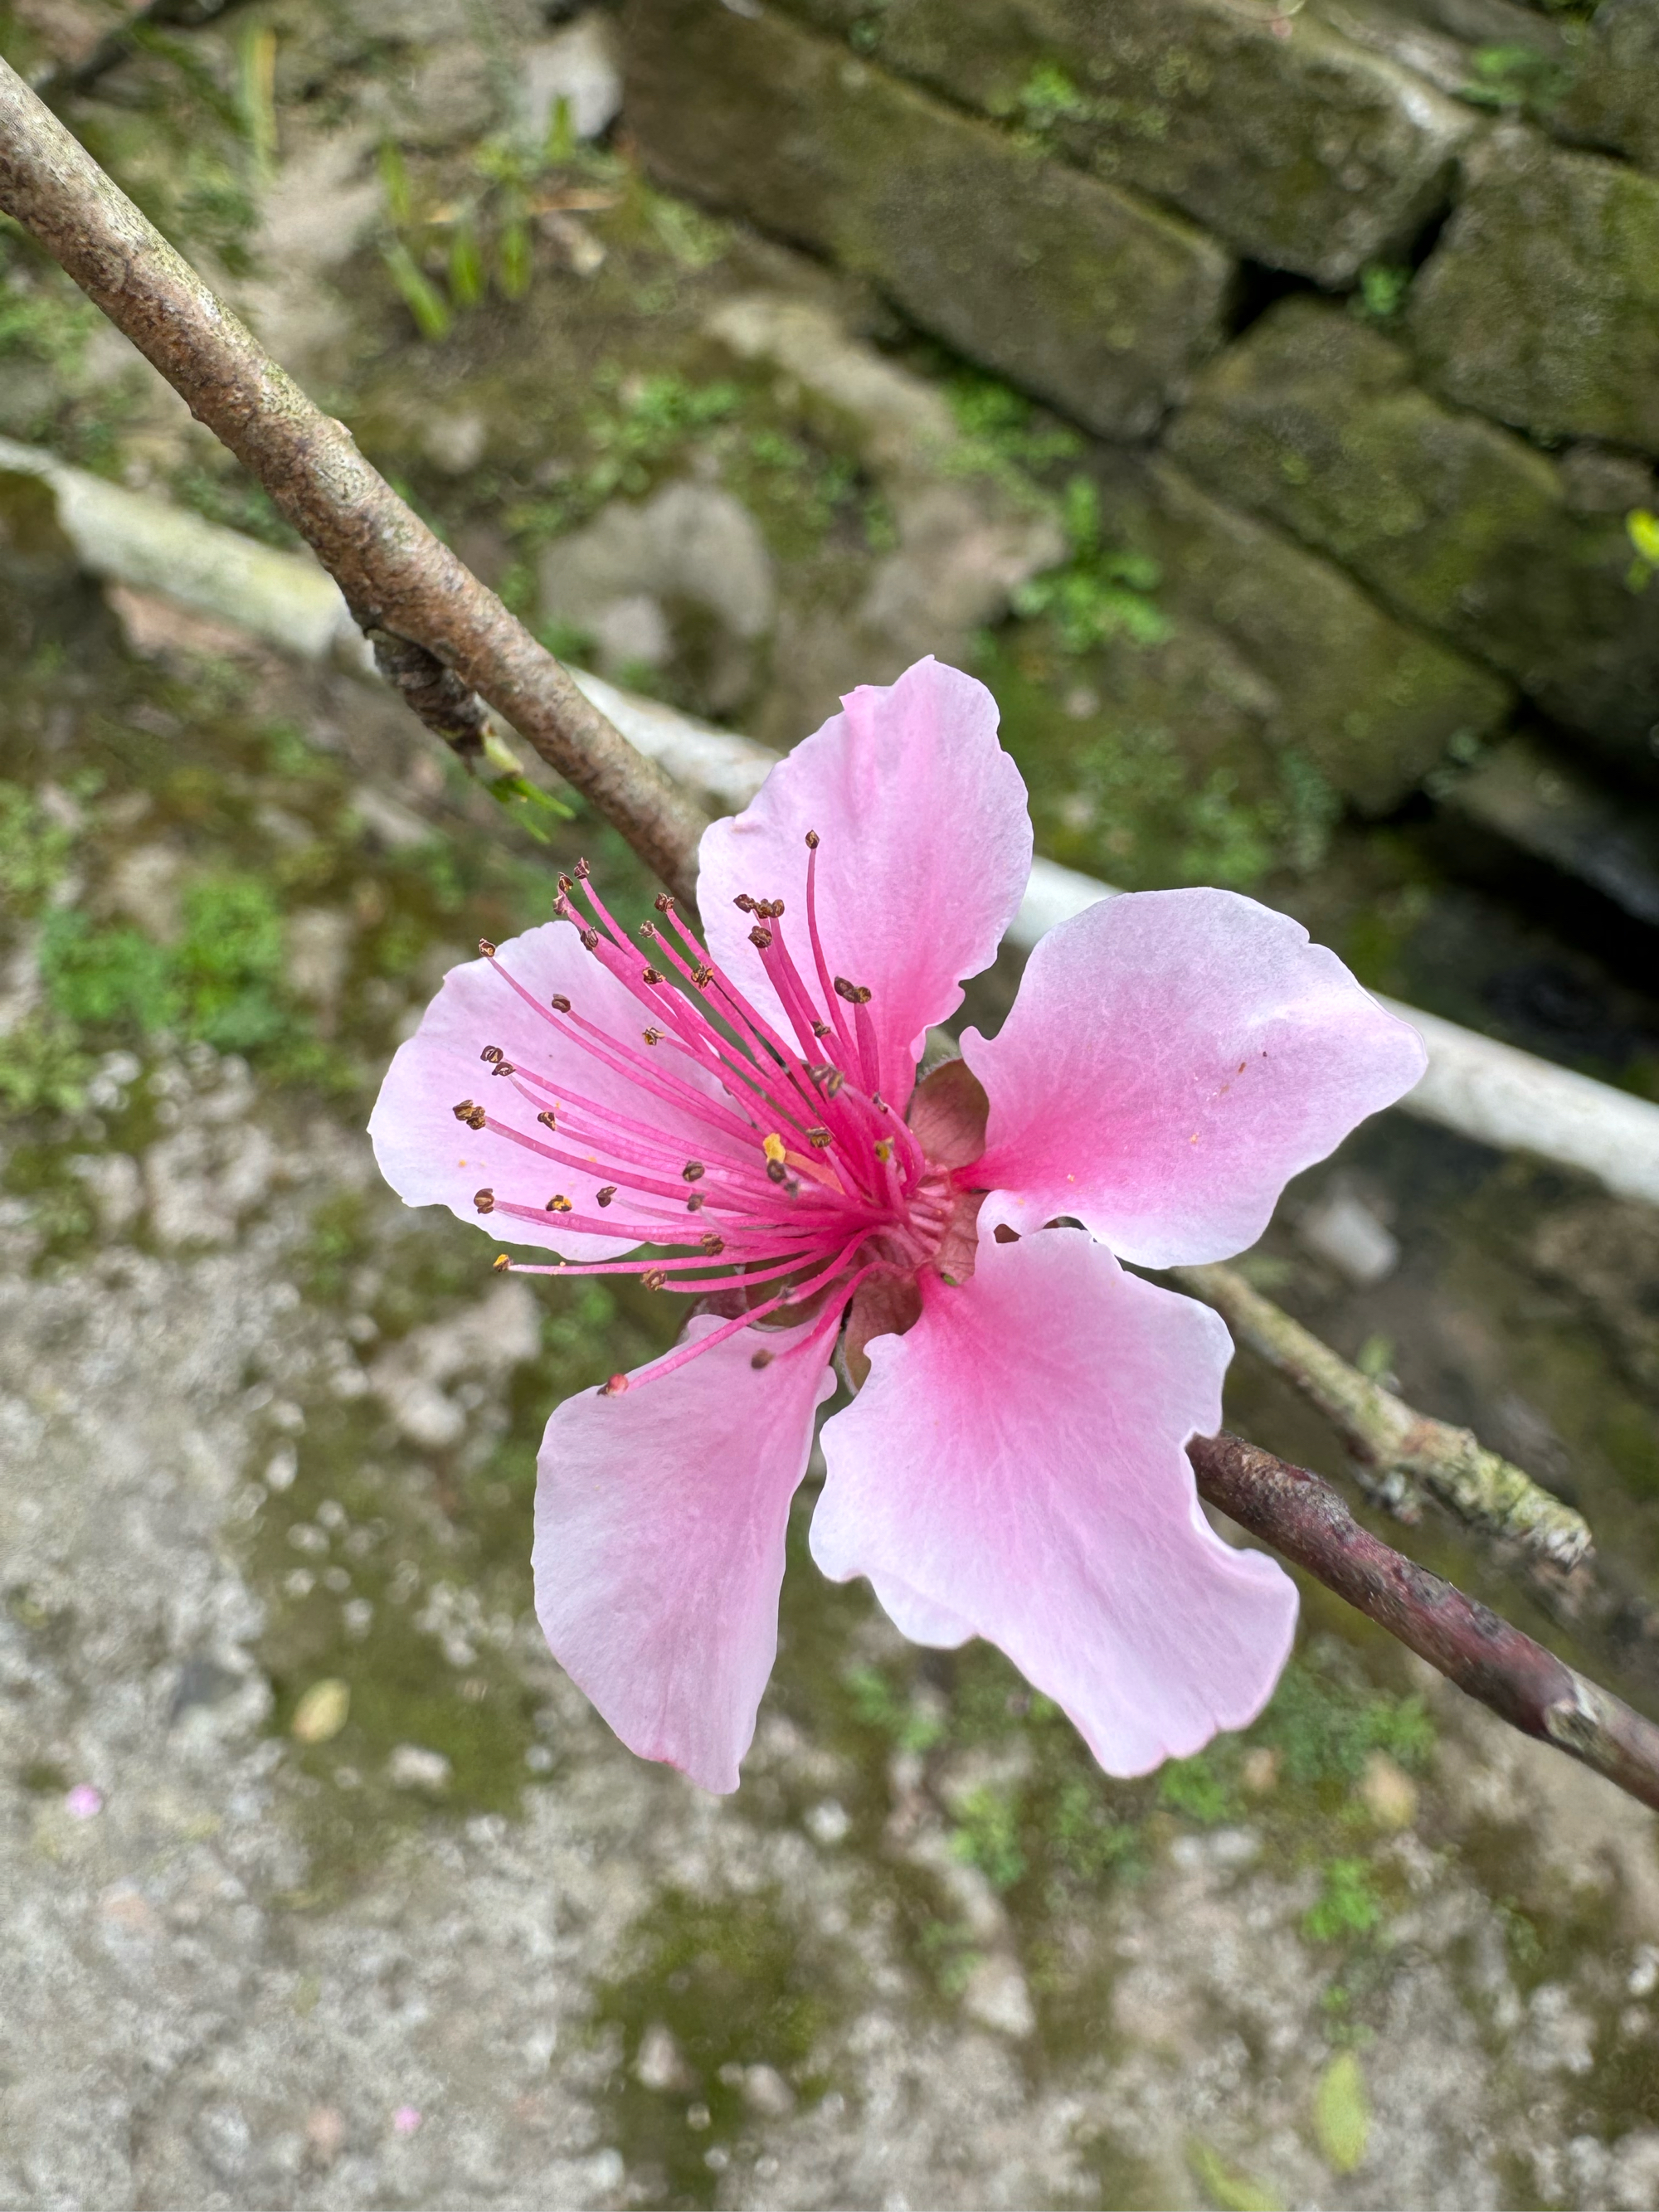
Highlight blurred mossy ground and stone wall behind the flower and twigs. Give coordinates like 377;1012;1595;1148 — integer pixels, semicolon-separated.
0;0;1659;2212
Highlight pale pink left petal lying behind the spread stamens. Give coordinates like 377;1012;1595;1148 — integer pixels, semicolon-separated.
369;922;738;1259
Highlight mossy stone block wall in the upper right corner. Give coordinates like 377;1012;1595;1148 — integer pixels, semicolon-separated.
624;0;1659;791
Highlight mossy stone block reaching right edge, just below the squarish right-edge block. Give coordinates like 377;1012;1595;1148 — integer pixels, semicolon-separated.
1168;299;1659;766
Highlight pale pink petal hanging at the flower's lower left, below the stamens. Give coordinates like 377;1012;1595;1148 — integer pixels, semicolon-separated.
533;1314;834;1791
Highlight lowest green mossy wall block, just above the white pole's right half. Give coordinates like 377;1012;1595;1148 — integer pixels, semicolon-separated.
1106;460;1511;814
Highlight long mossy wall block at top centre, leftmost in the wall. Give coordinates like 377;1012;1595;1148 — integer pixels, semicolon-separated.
624;0;1232;438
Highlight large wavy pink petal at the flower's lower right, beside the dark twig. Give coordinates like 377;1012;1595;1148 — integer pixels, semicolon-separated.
812;1230;1297;1774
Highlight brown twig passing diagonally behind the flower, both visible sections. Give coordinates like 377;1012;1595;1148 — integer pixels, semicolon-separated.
0;62;1659;1807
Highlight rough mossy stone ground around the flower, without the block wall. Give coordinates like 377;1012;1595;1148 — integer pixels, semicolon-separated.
0;0;1659;2212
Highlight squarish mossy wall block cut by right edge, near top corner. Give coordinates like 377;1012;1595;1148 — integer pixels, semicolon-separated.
1409;126;1659;454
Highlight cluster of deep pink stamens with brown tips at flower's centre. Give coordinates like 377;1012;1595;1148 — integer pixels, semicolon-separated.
454;832;973;1396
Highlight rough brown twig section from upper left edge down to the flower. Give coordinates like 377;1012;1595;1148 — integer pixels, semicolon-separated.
0;60;703;902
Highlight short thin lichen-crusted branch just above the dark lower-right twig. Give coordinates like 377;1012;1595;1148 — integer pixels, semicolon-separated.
1170;1267;1593;1568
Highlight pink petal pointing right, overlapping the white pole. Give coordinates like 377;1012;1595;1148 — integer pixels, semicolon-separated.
962;892;1427;1267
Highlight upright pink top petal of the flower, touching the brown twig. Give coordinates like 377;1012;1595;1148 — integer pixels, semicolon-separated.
697;659;1031;1106
